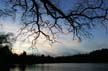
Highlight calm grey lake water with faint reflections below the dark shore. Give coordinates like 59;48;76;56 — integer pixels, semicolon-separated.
0;63;108;71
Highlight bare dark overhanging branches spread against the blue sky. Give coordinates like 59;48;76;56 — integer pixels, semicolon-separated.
1;0;108;44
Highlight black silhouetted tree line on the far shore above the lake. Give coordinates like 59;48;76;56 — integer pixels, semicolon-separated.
0;46;108;64
